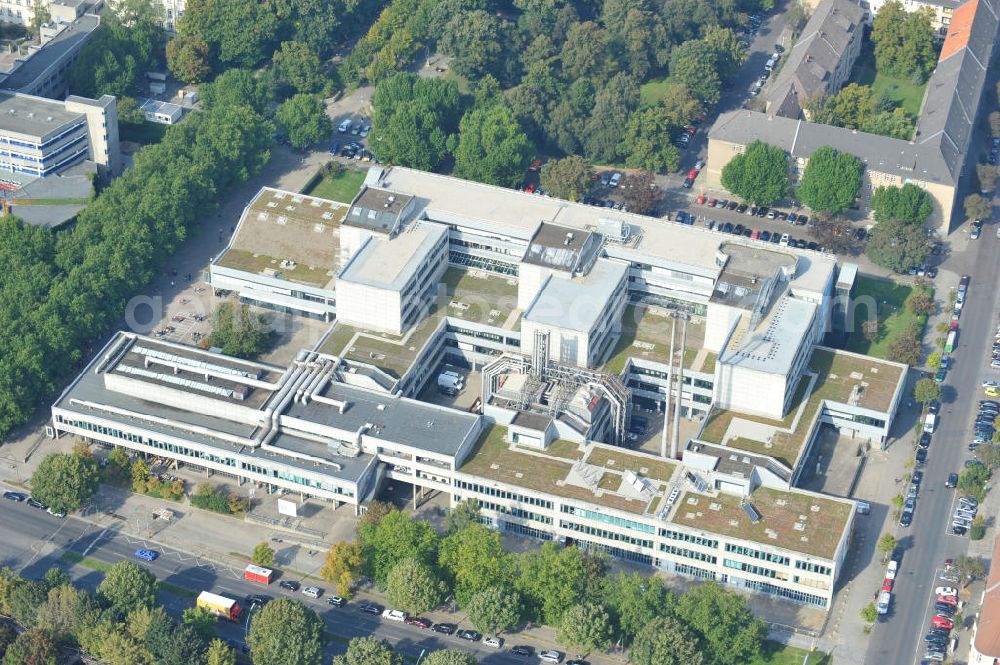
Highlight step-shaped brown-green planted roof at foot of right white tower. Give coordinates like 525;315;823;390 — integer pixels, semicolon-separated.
698;347;904;469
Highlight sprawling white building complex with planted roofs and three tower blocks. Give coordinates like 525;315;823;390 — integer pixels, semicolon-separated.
70;167;906;608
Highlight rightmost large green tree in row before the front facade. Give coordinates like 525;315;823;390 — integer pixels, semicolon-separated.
677;582;767;665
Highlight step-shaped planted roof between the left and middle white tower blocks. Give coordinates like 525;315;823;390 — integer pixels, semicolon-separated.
321;268;520;379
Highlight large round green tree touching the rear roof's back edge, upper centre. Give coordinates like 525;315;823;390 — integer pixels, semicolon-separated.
455;104;534;186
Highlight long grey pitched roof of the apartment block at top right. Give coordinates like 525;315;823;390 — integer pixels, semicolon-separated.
767;0;865;118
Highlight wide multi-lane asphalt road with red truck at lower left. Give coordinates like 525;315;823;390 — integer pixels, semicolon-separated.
0;498;584;665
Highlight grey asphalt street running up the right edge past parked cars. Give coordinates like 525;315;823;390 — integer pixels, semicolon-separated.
865;230;1000;665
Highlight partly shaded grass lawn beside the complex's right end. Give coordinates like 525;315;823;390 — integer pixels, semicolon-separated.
847;275;927;358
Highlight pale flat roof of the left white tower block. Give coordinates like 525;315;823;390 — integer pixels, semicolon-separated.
340;223;448;291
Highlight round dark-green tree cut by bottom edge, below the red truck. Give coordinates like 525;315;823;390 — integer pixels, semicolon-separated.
247;598;325;665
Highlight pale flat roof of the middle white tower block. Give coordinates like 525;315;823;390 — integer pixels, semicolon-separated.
524;259;628;333
